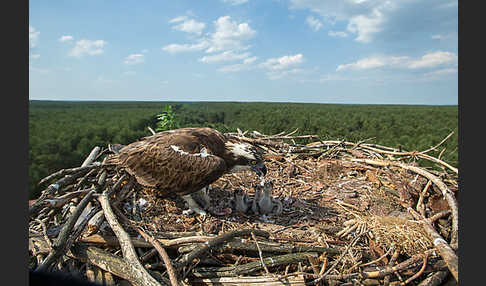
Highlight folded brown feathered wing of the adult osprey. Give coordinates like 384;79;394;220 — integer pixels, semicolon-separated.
118;134;227;195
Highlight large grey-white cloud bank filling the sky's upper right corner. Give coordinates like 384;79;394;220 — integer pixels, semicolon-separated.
289;0;457;43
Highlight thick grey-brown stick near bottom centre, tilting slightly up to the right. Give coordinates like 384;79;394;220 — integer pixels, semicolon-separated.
189;252;318;278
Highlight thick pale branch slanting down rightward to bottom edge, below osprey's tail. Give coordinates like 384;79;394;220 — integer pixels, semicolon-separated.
100;189;160;286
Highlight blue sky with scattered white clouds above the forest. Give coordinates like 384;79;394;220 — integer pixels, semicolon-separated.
29;0;458;104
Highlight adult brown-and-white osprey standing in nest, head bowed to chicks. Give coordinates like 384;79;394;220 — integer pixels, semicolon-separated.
105;128;267;215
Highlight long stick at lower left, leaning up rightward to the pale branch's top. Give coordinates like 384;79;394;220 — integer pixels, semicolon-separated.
35;190;95;271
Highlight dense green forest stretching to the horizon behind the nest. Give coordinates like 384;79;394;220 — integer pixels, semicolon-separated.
28;101;458;199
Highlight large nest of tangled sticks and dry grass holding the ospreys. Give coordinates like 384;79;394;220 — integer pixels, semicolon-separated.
29;130;458;285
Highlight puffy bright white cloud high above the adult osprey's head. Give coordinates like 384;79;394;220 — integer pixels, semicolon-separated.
206;16;256;53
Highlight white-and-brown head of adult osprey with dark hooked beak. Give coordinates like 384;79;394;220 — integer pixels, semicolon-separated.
225;141;267;178
